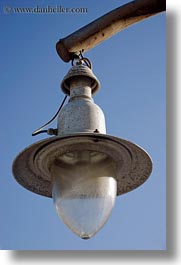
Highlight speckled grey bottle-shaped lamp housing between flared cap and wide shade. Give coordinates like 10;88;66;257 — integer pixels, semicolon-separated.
57;76;106;136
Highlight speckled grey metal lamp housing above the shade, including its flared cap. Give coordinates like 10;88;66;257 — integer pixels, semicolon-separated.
58;65;106;135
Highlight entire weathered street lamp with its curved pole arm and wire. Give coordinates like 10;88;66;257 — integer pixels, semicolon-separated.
13;0;165;239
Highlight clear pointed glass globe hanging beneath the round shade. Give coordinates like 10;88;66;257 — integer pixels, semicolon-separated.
51;151;117;239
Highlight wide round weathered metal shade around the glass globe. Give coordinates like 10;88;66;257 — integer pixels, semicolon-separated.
13;133;152;197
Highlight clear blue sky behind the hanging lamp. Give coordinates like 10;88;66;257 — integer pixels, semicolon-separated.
0;0;166;250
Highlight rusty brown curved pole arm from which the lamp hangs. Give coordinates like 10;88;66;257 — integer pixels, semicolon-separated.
56;0;166;62
